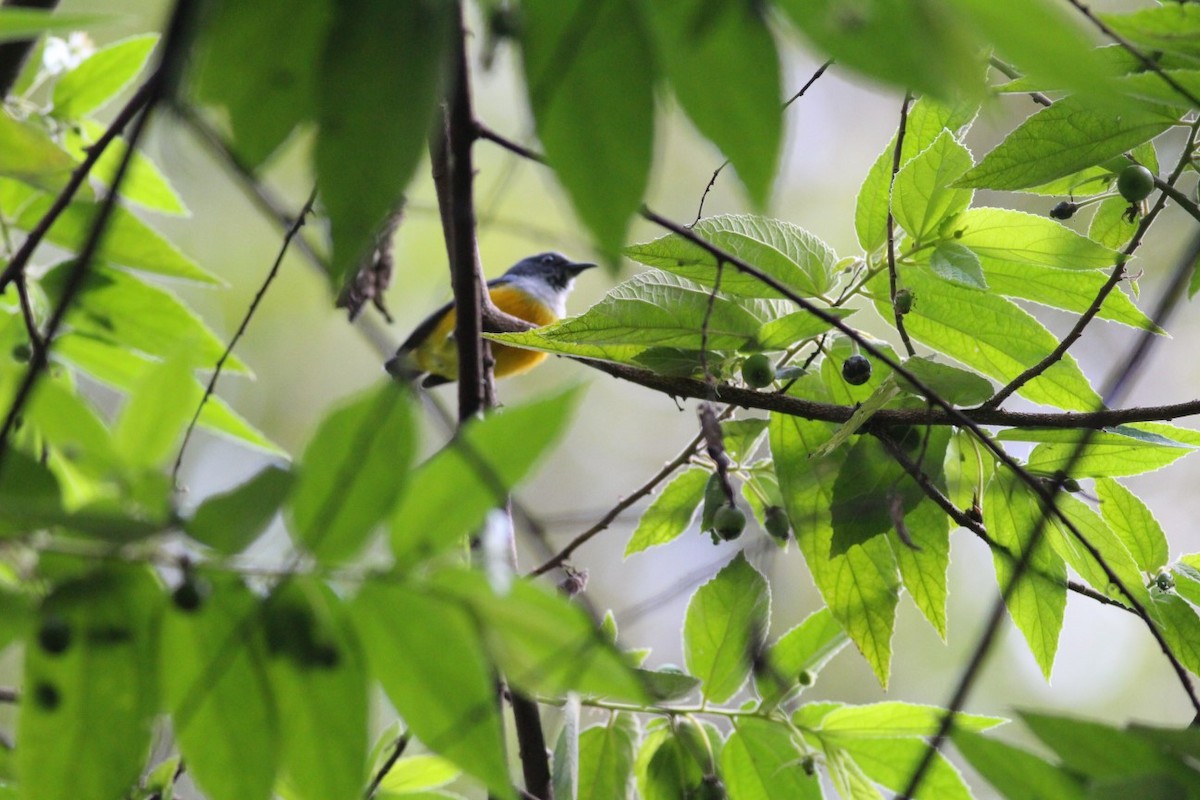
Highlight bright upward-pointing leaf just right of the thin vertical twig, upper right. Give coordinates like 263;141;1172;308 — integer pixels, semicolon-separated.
892;128;974;242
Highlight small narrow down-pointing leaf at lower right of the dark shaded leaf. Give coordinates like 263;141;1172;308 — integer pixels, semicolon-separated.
889;500;950;642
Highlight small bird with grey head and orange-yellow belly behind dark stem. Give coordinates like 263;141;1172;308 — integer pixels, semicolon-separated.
384;253;595;387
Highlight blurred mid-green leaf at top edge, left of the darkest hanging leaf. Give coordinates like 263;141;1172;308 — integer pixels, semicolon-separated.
196;0;331;167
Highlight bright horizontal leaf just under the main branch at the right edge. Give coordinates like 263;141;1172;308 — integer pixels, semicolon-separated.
997;425;1194;477
